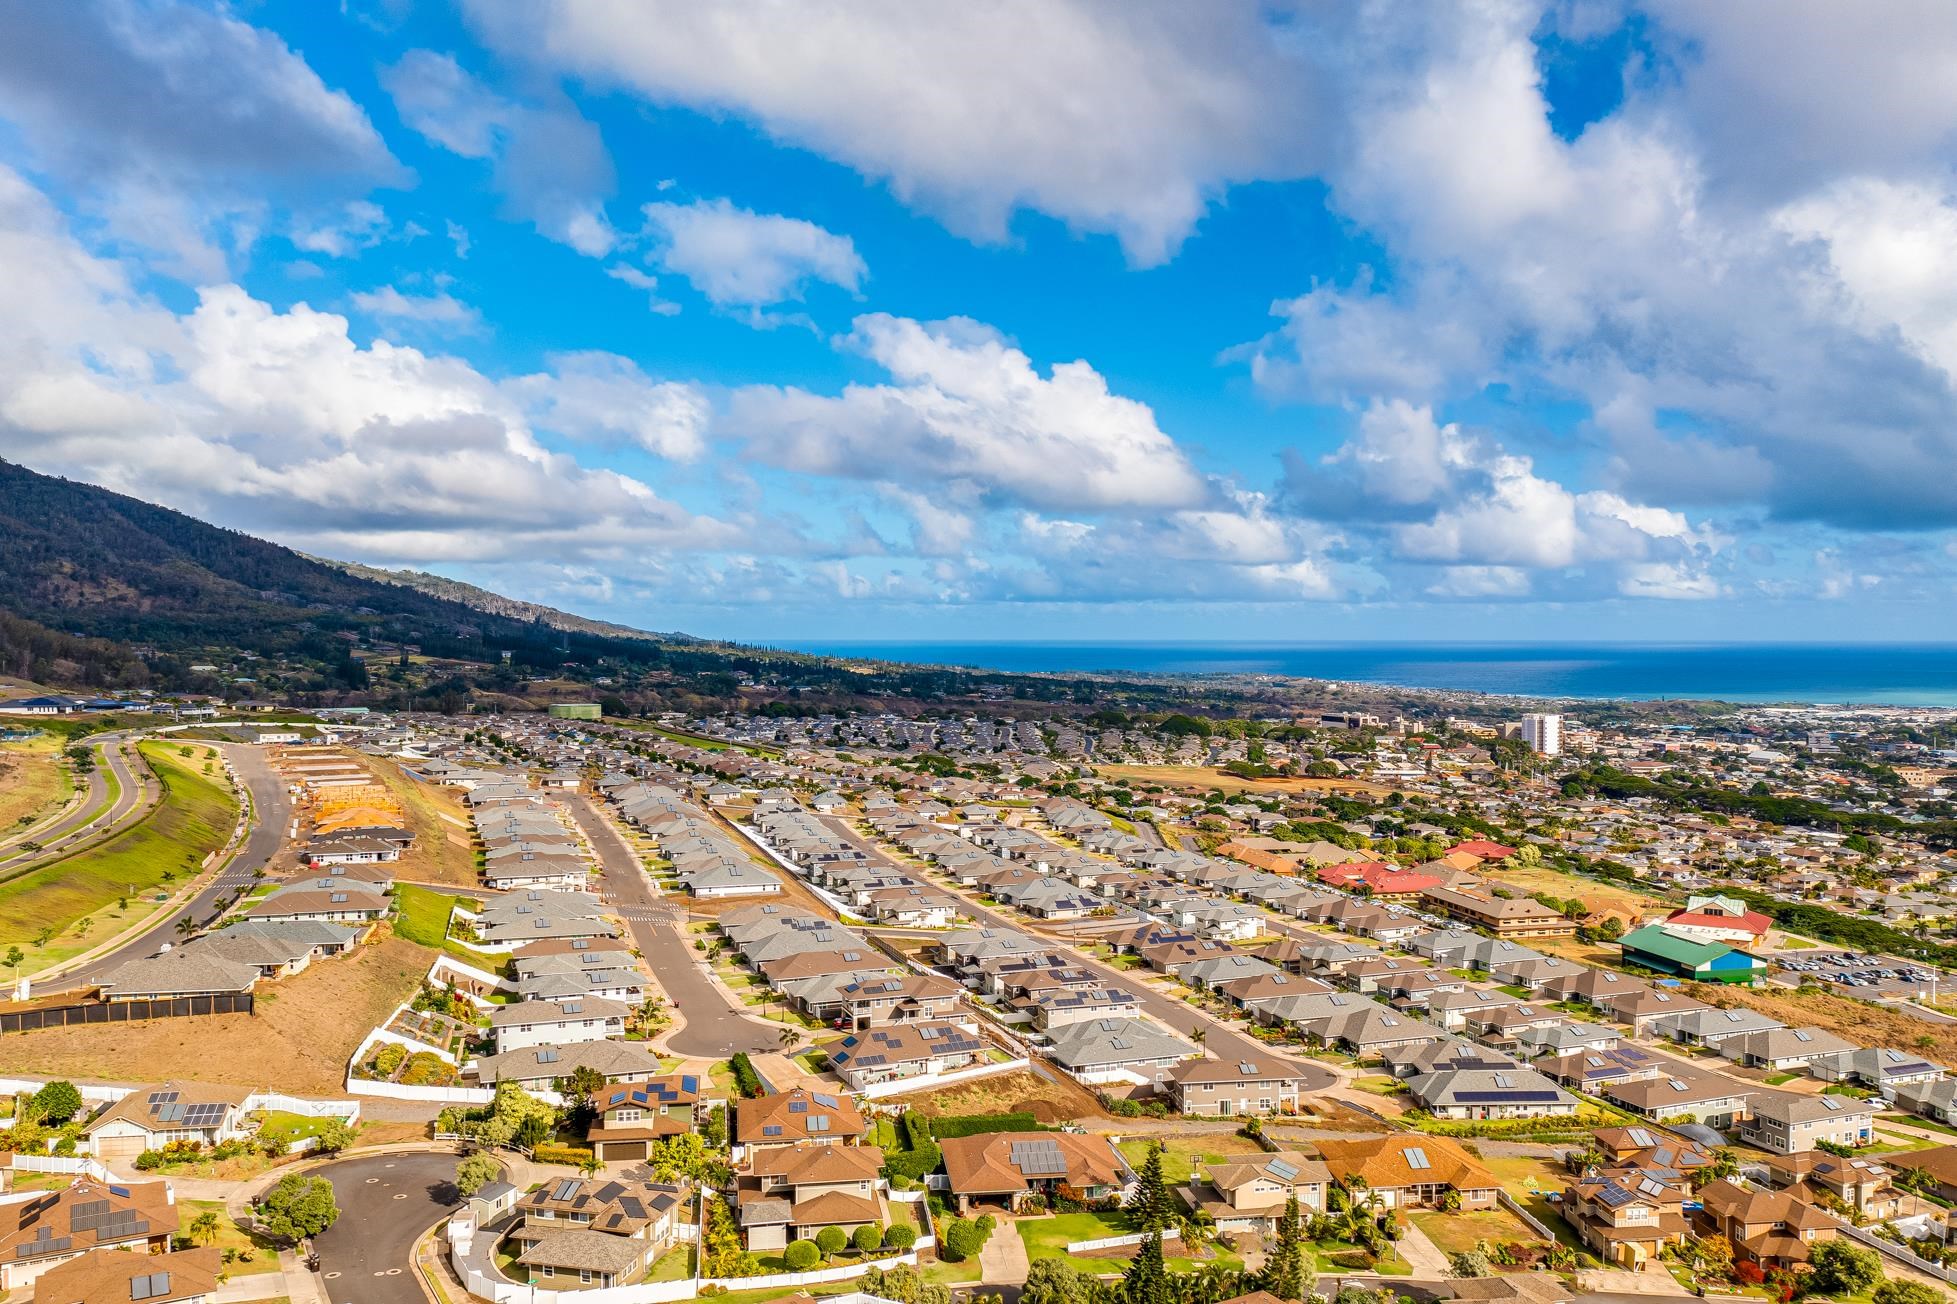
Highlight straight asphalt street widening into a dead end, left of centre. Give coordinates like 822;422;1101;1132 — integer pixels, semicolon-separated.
568;793;781;1059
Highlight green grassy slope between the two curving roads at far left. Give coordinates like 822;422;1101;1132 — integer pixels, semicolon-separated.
0;742;239;961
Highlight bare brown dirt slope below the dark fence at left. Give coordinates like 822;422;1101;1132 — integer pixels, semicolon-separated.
0;938;432;1094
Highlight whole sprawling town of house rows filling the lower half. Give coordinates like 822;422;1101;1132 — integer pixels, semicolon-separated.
11;693;1957;1304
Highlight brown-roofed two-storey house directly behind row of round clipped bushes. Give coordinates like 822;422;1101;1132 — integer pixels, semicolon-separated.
736;1141;888;1249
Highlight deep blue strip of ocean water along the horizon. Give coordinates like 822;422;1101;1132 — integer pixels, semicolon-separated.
774;642;1957;707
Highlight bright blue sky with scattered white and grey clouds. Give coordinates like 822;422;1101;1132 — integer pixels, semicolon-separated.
0;0;1957;642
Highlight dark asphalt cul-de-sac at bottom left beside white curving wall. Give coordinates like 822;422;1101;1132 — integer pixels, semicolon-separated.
313;1153;462;1304
